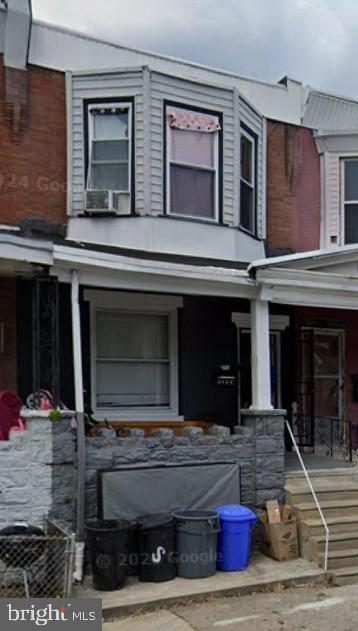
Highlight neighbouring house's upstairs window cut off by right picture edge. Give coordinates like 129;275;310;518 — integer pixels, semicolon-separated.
342;158;358;243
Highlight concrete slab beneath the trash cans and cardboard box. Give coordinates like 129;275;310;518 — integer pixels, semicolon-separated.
77;553;329;620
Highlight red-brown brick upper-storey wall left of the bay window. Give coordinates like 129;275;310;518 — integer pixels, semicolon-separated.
0;58;66;224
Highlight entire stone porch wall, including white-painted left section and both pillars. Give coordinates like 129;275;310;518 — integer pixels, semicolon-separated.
0;411;284;528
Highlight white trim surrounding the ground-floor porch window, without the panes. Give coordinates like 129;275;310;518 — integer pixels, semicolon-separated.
84;290;183;421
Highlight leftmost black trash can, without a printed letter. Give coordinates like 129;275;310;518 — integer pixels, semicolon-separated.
86;519;130;591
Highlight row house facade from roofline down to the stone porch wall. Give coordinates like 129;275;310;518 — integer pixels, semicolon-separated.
0;1;358;528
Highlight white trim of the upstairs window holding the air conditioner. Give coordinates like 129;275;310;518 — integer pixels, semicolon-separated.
84;101;134;215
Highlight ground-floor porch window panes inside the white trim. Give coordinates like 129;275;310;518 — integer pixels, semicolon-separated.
96;310;170;409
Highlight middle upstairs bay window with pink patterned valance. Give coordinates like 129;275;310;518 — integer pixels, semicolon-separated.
166;106;221;221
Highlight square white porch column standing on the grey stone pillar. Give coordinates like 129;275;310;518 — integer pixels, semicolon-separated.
250;300;273;410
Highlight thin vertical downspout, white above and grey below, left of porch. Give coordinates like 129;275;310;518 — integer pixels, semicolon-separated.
71;270;86;541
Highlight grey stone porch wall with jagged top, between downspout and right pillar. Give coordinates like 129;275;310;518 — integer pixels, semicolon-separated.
86;426;256;519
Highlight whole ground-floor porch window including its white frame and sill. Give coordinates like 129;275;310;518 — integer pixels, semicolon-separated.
86;291;182;420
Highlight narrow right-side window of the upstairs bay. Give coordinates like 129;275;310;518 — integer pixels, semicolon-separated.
240;128;256;234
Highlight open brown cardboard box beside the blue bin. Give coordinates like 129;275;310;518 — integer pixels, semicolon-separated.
259;506;299;561
